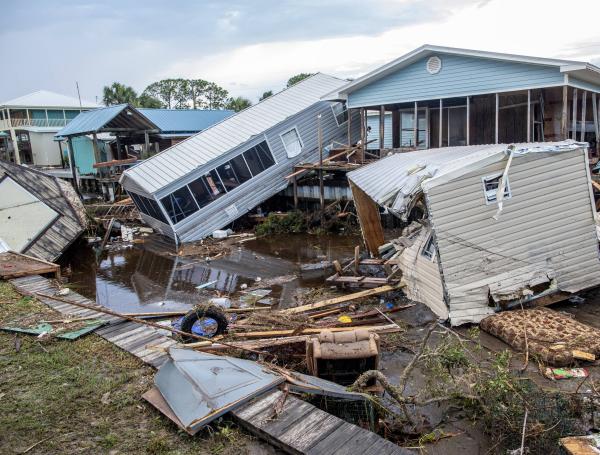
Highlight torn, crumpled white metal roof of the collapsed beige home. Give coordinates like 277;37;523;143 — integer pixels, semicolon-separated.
348;140;587;216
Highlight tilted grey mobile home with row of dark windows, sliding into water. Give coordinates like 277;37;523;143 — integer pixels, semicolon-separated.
121;73;359;242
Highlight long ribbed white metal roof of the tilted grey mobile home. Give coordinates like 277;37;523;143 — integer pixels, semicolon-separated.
123;73;346;193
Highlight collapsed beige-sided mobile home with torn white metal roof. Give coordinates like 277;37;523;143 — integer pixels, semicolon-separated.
348;141;600;325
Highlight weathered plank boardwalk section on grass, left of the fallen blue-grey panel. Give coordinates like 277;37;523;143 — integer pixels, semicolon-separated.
10;275;178;368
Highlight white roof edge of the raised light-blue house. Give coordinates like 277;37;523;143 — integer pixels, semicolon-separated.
323;44;600;100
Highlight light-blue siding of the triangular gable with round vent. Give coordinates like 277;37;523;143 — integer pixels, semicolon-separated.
348;53;564;108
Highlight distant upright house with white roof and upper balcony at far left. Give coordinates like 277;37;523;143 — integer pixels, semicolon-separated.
0;90;99;166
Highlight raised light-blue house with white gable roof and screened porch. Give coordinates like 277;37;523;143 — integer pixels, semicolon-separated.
324;45;600;153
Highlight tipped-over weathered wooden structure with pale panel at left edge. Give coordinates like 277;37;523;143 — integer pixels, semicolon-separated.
0;160;87;261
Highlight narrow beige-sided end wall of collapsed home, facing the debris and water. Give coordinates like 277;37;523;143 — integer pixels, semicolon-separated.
398;229;448;319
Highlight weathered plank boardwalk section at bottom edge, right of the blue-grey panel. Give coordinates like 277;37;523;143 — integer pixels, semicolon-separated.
230;390;414;455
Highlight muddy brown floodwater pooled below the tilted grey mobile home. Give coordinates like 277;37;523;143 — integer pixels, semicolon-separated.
62;234;359;313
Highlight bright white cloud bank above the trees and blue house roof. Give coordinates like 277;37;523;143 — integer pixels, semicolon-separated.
159;0;600;100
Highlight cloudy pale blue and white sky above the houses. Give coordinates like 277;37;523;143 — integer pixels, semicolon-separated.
0;0;600;101
